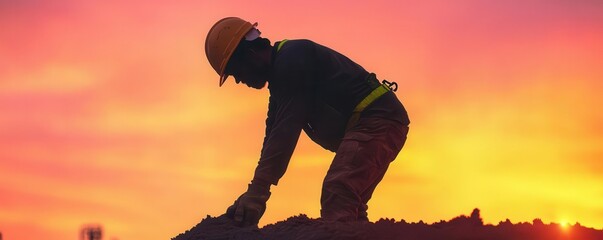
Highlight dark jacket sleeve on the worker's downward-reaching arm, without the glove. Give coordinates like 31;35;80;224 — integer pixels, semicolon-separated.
253;42;313;185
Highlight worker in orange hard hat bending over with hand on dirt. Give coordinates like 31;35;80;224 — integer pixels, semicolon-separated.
205;17;410;226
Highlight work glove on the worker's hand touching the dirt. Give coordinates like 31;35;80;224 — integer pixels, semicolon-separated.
226;182;270;227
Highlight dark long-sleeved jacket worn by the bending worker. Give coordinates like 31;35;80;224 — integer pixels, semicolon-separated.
254;40;409;185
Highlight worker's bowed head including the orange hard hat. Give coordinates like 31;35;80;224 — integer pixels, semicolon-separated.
205;17;271;89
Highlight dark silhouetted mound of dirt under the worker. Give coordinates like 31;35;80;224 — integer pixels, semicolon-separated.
172;209;603;240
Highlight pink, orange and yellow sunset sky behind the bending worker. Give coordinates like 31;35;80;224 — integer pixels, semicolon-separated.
0;0;603;240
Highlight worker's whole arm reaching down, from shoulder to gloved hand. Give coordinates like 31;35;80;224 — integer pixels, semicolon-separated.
226;40;314;226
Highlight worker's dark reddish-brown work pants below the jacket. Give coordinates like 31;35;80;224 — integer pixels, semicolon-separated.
320;118;408;221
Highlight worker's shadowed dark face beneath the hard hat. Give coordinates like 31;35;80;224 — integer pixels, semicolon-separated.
226;49;270;89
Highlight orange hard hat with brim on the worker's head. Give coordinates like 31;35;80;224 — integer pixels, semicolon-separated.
205;17;258;86
